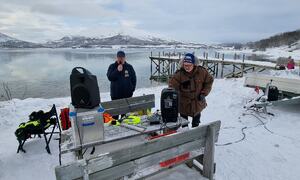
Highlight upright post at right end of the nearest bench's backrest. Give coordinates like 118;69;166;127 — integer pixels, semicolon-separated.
203;125;216;180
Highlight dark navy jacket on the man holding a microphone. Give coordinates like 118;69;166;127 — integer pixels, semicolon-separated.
106;62;136;99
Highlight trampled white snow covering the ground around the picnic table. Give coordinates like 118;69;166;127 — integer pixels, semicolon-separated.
0;79;300;180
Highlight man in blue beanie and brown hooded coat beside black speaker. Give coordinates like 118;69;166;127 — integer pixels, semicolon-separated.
169;53;213;127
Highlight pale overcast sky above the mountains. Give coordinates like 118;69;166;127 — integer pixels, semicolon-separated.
0;0;300;43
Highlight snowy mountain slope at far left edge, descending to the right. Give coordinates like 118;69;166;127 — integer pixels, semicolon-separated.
0;33;43;48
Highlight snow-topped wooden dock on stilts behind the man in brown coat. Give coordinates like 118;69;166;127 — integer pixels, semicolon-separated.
149;52;276;81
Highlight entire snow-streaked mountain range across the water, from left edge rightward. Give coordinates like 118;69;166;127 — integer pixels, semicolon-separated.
0;33;211;48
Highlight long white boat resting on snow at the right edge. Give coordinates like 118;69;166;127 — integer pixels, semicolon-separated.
244;70;300;96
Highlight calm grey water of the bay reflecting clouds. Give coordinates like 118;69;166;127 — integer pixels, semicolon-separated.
0;49;218;100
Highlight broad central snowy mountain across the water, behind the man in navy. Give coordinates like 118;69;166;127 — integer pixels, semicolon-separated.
46;34;182;48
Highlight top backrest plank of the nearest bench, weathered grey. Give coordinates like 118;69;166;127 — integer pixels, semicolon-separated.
56;121;221;179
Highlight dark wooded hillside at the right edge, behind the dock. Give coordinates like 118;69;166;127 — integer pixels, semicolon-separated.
246;30;300;50
